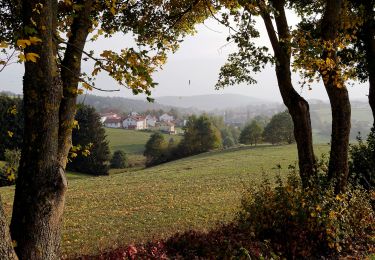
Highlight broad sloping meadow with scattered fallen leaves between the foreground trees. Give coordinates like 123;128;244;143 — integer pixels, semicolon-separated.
0;145;328;255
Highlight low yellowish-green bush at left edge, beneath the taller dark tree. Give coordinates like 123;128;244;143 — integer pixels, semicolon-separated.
0;149;21;186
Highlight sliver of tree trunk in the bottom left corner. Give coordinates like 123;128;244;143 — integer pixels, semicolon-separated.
0;197;17;260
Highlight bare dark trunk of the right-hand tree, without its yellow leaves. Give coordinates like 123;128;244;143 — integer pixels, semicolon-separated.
321;0;351;192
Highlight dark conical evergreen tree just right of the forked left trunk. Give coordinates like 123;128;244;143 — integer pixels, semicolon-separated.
67;106;110;175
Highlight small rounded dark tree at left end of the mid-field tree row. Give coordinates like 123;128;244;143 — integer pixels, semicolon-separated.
143;133;168;166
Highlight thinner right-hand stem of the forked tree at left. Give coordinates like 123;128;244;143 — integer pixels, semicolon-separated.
59;0;93;169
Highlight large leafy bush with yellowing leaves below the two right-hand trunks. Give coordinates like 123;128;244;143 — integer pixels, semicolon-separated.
238;173;375;258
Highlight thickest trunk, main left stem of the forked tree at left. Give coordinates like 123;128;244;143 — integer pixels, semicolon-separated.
11;0;67;260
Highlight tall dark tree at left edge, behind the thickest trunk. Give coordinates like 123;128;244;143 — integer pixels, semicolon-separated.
0;95;23;160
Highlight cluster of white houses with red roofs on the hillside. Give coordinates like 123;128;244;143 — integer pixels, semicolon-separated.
100;112;186;134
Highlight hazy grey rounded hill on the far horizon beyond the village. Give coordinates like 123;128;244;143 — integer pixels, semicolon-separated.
155;94;275;111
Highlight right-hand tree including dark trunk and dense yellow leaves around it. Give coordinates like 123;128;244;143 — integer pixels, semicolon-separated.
295;0;361;192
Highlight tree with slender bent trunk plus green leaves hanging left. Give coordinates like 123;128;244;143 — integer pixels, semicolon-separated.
216;0;315;187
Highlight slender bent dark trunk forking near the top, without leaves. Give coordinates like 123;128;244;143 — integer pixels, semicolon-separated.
259;1;315;187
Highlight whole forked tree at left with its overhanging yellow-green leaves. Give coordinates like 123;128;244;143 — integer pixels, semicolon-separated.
0;0;212;259
